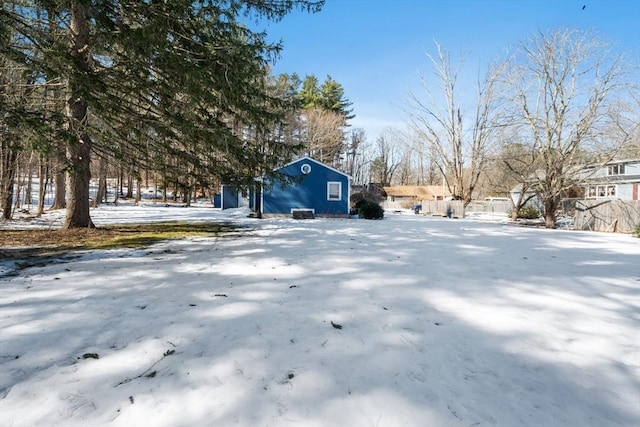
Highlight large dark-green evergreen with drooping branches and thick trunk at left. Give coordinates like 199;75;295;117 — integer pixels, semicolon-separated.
0;0;324;228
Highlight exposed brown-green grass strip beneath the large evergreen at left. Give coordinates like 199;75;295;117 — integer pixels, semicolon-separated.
0;221;245;259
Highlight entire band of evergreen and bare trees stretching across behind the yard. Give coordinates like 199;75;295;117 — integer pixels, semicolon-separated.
0;0;640;228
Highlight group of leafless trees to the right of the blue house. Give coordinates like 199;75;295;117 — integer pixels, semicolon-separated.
362;29;640;227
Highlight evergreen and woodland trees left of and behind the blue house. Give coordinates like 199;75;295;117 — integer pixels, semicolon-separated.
0;0;360;228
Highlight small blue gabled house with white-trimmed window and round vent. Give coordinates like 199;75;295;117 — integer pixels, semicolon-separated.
255;157;351;217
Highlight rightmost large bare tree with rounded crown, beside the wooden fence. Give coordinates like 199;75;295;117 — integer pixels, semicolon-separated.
507;30;637;228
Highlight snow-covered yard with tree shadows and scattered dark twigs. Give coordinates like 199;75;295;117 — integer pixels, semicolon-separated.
0;205;640;427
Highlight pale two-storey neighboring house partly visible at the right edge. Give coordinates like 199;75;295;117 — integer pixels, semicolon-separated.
581;159;640;200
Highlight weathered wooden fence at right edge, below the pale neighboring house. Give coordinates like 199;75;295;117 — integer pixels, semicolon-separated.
574;200;640;233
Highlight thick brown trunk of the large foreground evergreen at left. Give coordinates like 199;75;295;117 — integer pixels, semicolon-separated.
63;2;95;229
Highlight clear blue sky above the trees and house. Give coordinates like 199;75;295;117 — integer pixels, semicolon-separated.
256;0;640;141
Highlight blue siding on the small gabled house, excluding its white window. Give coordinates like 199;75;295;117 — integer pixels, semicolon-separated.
262;157;349;216
